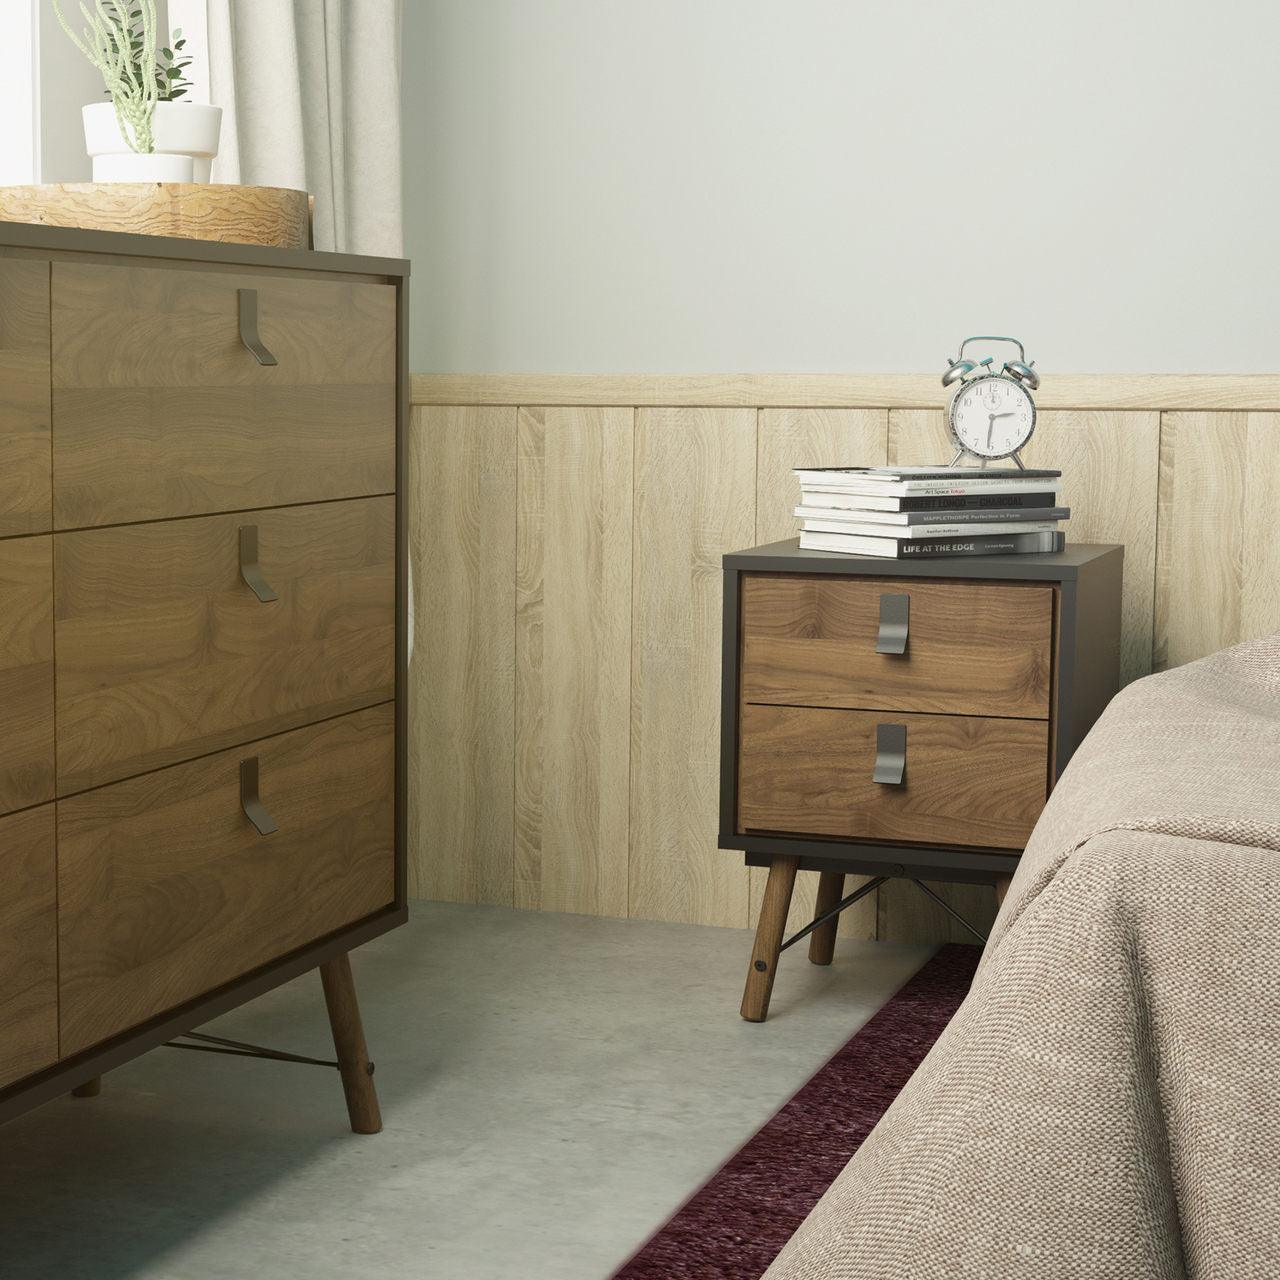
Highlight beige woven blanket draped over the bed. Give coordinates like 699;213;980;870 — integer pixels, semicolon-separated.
767;634;1280;1280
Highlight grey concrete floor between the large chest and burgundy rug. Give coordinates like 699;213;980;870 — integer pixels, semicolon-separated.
0;904;932;1280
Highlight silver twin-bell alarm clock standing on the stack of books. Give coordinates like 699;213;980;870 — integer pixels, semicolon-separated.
942;337;1039;470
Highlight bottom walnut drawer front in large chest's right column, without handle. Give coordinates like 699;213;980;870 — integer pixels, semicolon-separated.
58;705;396;1057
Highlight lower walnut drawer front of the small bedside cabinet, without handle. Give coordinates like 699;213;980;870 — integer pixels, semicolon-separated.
739;705;1048;849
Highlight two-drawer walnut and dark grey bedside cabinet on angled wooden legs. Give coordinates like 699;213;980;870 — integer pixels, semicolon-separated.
719;540;1124;1021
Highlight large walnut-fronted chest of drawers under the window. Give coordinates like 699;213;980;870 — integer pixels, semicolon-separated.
0;224;407;1132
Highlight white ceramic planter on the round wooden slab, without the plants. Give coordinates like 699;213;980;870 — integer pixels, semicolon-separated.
84;101;223;182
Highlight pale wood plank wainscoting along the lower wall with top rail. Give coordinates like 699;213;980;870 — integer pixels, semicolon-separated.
410;374;1280;941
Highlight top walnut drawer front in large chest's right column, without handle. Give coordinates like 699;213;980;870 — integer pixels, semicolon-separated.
51;262;396;529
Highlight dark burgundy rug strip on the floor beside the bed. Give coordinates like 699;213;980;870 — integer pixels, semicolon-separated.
613;946;982;1280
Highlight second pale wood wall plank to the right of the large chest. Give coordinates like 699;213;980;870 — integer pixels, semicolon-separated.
516;408;635;916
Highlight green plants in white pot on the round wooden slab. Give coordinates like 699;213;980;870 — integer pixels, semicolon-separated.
52;0;223;182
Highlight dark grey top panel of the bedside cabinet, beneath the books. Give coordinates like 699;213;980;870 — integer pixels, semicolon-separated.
724;538;1124;582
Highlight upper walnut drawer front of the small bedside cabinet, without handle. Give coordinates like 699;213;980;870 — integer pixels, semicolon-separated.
741;573;1053;719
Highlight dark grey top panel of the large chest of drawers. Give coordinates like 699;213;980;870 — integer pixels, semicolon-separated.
0;221;410;278
